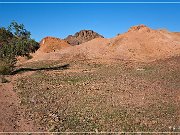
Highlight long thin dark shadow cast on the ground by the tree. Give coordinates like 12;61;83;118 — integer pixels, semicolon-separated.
11;64;69;75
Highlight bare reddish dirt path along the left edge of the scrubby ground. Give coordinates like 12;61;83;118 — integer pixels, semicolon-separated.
0;72;40;132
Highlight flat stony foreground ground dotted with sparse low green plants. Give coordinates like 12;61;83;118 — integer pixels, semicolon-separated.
16;58;180;132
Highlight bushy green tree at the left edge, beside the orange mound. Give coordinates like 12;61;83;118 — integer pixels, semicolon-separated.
0;22;39;74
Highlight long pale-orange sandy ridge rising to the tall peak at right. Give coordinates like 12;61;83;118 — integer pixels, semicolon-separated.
30;25;180;62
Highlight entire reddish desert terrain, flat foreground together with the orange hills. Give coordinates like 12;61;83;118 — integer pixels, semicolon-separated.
0;25;180;133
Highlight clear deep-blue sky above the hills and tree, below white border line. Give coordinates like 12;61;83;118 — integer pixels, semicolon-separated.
0;0;180;41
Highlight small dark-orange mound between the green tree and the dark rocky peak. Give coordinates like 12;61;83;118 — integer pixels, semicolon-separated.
39;37;70;53
